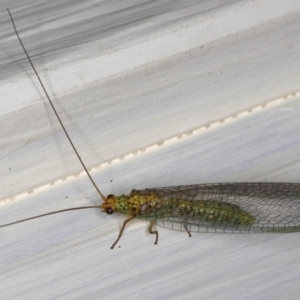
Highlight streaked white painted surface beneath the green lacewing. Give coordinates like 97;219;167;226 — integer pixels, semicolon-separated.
0;0;300;299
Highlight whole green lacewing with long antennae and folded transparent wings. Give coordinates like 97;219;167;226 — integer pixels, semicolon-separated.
0;10;300;249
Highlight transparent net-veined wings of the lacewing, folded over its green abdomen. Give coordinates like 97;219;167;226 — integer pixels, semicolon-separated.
137;183;300;233
